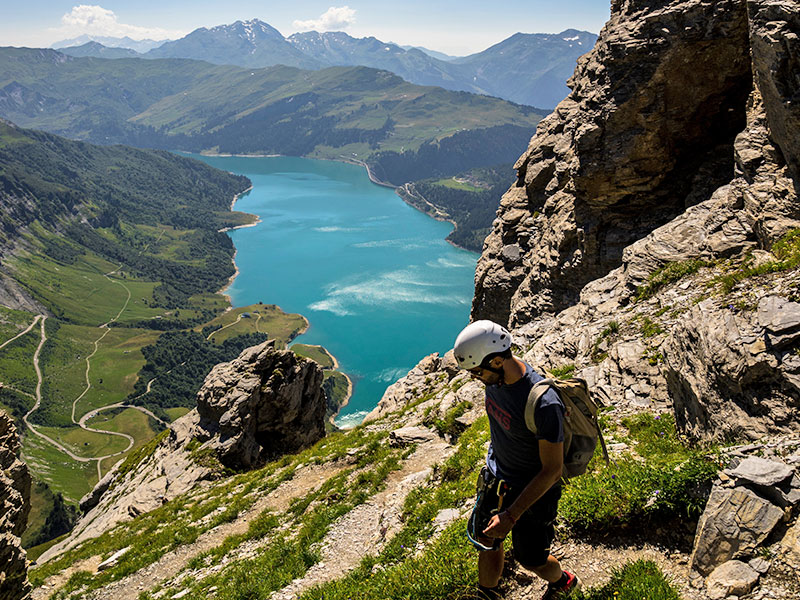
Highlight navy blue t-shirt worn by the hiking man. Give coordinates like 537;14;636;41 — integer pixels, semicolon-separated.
486;364;564;488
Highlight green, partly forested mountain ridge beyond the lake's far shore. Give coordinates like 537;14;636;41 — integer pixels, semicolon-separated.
0;48;543;185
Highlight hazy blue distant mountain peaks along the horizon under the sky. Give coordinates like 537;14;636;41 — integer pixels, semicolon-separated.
56;19;597;109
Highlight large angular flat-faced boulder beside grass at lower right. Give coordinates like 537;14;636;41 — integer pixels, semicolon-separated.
691;485;784;575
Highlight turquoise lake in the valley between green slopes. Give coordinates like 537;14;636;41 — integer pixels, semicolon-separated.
193;155;478;427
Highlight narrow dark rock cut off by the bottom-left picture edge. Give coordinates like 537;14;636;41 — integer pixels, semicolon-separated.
0;411;31;600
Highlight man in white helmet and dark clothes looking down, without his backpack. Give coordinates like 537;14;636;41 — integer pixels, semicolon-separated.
454;321;580;600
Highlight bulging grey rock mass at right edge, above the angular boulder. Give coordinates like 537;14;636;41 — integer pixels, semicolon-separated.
664;296;800;438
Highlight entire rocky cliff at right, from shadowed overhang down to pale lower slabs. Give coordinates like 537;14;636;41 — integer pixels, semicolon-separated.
466;0;800;438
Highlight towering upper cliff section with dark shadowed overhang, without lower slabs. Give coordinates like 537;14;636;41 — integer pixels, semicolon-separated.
472;0;752;326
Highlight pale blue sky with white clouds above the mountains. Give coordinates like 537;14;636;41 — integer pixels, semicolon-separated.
0;0;610;56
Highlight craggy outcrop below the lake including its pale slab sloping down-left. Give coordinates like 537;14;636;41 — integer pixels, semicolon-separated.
39;341;325;563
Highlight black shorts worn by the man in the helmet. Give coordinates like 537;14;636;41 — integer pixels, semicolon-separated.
481;474;561;568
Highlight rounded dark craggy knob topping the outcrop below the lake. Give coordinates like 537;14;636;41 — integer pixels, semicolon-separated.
195;341;325;469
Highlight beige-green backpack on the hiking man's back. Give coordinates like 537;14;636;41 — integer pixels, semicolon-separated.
525;377;609;479
